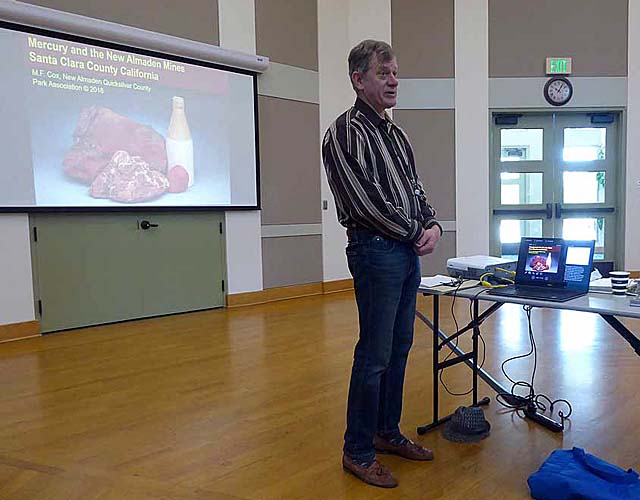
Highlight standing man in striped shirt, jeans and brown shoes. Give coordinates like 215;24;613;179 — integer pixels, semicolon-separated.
322;40;442;488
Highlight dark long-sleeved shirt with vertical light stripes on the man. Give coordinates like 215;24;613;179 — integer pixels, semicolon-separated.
322;98;442;242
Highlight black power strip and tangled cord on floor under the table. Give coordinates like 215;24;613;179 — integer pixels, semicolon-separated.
496;305;573;432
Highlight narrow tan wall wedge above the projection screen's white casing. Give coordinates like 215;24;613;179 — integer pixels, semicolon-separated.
25;0;219;45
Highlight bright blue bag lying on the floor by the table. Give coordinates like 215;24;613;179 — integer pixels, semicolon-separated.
527;448;640;500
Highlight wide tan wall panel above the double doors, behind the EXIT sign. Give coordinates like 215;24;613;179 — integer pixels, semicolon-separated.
489;0;628;77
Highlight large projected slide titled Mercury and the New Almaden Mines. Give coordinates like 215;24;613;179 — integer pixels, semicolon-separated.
0;24;257;209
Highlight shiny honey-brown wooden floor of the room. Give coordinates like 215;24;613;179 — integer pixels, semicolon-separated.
0;292;640;500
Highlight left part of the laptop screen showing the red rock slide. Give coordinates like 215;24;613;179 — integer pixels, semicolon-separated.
516;238;565;286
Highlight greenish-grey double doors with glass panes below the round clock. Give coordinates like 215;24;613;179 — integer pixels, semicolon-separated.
490;112;620;261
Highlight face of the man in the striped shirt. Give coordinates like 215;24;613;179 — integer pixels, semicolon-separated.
352;54;398;114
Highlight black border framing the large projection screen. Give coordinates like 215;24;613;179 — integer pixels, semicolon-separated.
0;20;262;213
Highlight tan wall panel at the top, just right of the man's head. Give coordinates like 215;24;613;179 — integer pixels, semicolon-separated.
391;0;454;78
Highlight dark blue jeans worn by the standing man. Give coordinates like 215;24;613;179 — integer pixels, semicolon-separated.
344;229;420;462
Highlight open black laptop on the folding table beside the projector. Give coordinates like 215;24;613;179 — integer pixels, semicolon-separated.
488;238;595;302
